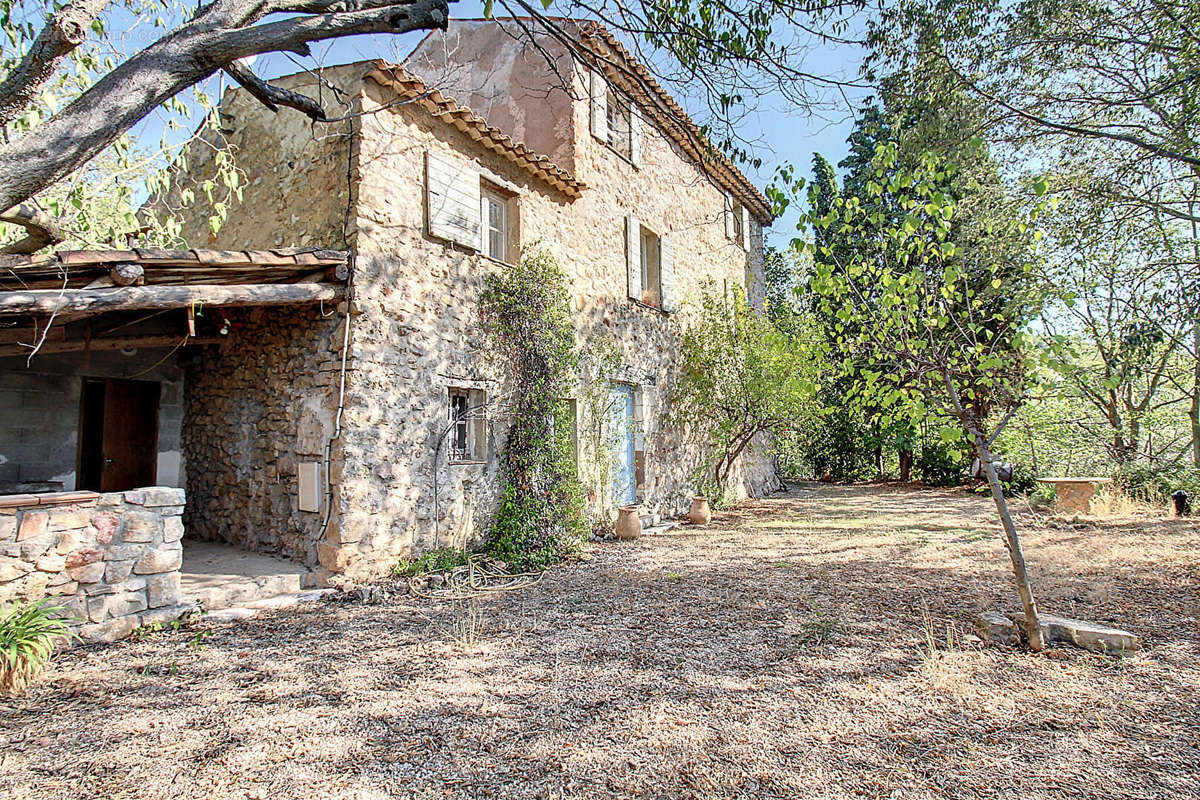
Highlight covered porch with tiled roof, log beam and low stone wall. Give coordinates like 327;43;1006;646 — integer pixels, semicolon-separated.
0;248;347;639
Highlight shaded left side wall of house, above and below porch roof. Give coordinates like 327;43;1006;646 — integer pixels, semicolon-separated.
166;66;365;567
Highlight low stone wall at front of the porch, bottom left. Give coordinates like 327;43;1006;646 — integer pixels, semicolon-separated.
0;487;190;642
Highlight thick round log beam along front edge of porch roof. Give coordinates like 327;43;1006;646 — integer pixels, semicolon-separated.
0;283;346;317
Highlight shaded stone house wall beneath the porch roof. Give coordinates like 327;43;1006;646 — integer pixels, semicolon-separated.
184;307;343;566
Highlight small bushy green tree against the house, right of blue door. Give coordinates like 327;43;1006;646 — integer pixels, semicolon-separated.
674;291;821;501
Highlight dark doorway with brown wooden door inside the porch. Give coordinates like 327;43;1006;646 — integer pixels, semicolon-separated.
77;378;161;492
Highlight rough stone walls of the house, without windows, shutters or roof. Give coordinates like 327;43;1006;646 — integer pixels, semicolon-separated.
169;54;774;577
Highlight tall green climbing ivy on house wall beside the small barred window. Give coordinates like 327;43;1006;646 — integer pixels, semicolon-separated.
481;251;587;570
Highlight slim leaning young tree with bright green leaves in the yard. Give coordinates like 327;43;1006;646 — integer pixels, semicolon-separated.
802;143;1043;650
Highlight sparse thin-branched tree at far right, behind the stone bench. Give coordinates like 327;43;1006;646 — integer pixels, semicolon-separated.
1043;173;1196;467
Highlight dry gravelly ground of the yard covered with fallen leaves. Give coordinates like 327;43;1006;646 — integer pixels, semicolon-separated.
0;486;1200;800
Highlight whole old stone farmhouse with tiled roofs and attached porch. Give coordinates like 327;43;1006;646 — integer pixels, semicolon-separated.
0;20;775;637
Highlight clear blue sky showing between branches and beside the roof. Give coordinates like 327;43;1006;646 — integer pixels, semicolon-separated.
126;0;865;246
